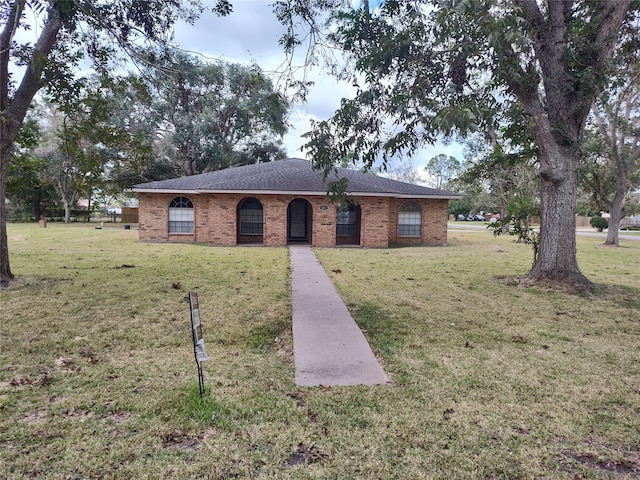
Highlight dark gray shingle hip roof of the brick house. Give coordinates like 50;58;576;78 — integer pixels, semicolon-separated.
134;158;459;199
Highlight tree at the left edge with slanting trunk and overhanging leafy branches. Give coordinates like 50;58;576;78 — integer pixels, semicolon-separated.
0;0;230;285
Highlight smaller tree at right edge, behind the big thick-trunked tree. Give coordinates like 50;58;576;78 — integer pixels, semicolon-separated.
582;68;640;247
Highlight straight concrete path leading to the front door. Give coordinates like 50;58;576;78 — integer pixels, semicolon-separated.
289;245;389;386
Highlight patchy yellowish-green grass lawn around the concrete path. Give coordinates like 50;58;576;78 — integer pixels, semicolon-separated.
0;224;640;479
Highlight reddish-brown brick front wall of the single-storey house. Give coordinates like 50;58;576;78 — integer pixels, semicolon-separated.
139;193;447;247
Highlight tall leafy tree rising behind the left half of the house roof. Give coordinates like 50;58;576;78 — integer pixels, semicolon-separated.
144;51;289;175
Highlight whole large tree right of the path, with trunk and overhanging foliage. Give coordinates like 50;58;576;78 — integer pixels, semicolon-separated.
298;0;640;291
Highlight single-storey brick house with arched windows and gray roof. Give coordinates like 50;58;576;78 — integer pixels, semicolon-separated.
134;158;459;247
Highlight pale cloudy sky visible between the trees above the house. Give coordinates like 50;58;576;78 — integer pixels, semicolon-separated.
174;0;462;173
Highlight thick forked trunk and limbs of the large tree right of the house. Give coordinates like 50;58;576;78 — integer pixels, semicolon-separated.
505;0;631;292
